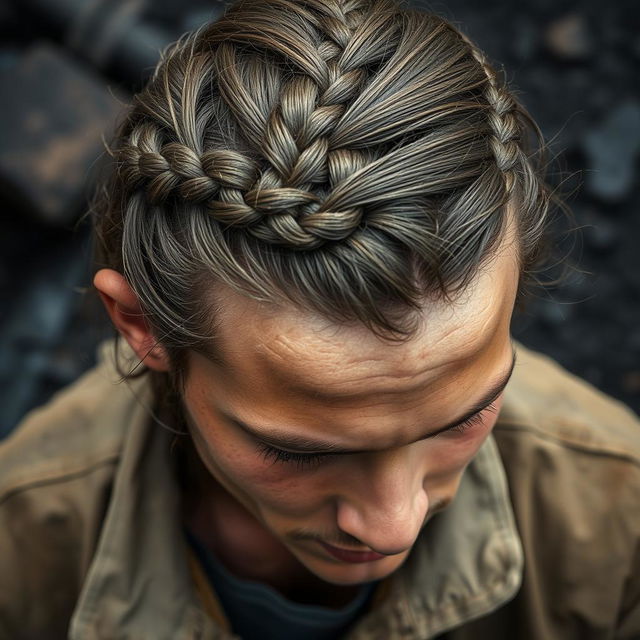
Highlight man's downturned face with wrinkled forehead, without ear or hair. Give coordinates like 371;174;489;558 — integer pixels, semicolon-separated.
183;229;518;585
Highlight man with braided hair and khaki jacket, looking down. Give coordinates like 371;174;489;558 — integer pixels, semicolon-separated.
0;0;640;640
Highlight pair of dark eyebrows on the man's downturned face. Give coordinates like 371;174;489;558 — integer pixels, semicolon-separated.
222;349;516;455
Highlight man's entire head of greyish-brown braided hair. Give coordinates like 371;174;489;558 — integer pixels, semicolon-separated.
94;0;564;388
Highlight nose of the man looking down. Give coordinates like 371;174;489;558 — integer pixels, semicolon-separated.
337;450;429;555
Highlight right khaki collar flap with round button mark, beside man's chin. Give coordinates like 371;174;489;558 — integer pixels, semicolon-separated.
349;436;524;640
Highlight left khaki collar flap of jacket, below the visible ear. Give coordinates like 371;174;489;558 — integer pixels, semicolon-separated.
69;345;230;640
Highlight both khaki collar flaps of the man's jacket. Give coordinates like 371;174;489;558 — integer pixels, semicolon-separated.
70;342;523;640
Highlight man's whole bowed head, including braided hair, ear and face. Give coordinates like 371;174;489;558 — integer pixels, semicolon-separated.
95;0;550;584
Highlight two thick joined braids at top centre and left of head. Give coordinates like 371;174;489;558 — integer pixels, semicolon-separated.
119;2;392;249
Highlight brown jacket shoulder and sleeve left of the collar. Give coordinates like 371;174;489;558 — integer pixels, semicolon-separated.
0;343;154;639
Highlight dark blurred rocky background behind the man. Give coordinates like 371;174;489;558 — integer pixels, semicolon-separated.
0;0;640;437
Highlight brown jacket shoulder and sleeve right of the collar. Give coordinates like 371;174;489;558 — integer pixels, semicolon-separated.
492;345;640;639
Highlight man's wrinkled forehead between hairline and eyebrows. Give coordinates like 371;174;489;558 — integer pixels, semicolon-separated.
205;230;518;396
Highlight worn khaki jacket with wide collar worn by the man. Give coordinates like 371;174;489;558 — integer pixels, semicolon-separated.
0;343;640;640
